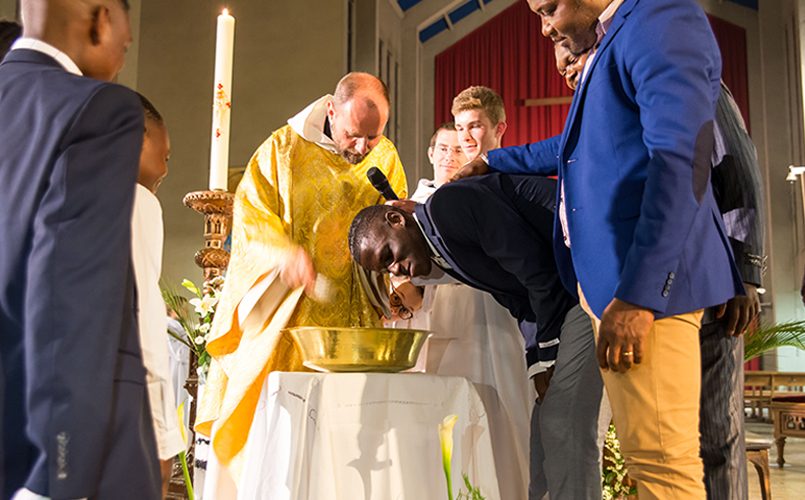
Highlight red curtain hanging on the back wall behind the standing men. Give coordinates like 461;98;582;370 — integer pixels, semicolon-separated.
434;2;749;146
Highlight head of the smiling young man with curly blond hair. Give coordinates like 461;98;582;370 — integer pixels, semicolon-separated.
451;86;506;160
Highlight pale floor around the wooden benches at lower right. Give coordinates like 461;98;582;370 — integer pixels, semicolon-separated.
746;422;805;500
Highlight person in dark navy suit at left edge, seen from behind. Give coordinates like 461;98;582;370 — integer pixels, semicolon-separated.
0;0;160;499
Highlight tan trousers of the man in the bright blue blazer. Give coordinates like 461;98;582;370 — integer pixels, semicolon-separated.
579;290;706;500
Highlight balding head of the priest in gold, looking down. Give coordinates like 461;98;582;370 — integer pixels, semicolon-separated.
327;73;389;164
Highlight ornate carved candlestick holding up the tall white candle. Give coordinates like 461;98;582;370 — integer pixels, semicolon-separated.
168;191;235;499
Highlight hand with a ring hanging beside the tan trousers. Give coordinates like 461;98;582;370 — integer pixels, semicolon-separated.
596;299;654;373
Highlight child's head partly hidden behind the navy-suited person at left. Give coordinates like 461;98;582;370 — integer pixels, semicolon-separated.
137;94;170;193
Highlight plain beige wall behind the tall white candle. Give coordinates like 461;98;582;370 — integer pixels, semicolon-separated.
136;0;346;284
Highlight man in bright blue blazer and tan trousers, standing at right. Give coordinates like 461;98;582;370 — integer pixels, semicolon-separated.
457;0;744;499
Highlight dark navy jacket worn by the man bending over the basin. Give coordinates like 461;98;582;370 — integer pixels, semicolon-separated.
415;174;578;366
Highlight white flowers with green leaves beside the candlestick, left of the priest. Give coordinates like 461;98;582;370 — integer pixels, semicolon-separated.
162;276;224;384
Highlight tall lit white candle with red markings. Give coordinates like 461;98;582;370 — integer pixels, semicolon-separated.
210;9;235;191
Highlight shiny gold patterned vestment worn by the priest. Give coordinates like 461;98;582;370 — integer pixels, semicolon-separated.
195;125;407;464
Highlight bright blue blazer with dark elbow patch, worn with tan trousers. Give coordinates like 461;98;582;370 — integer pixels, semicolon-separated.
489;0;744;317
